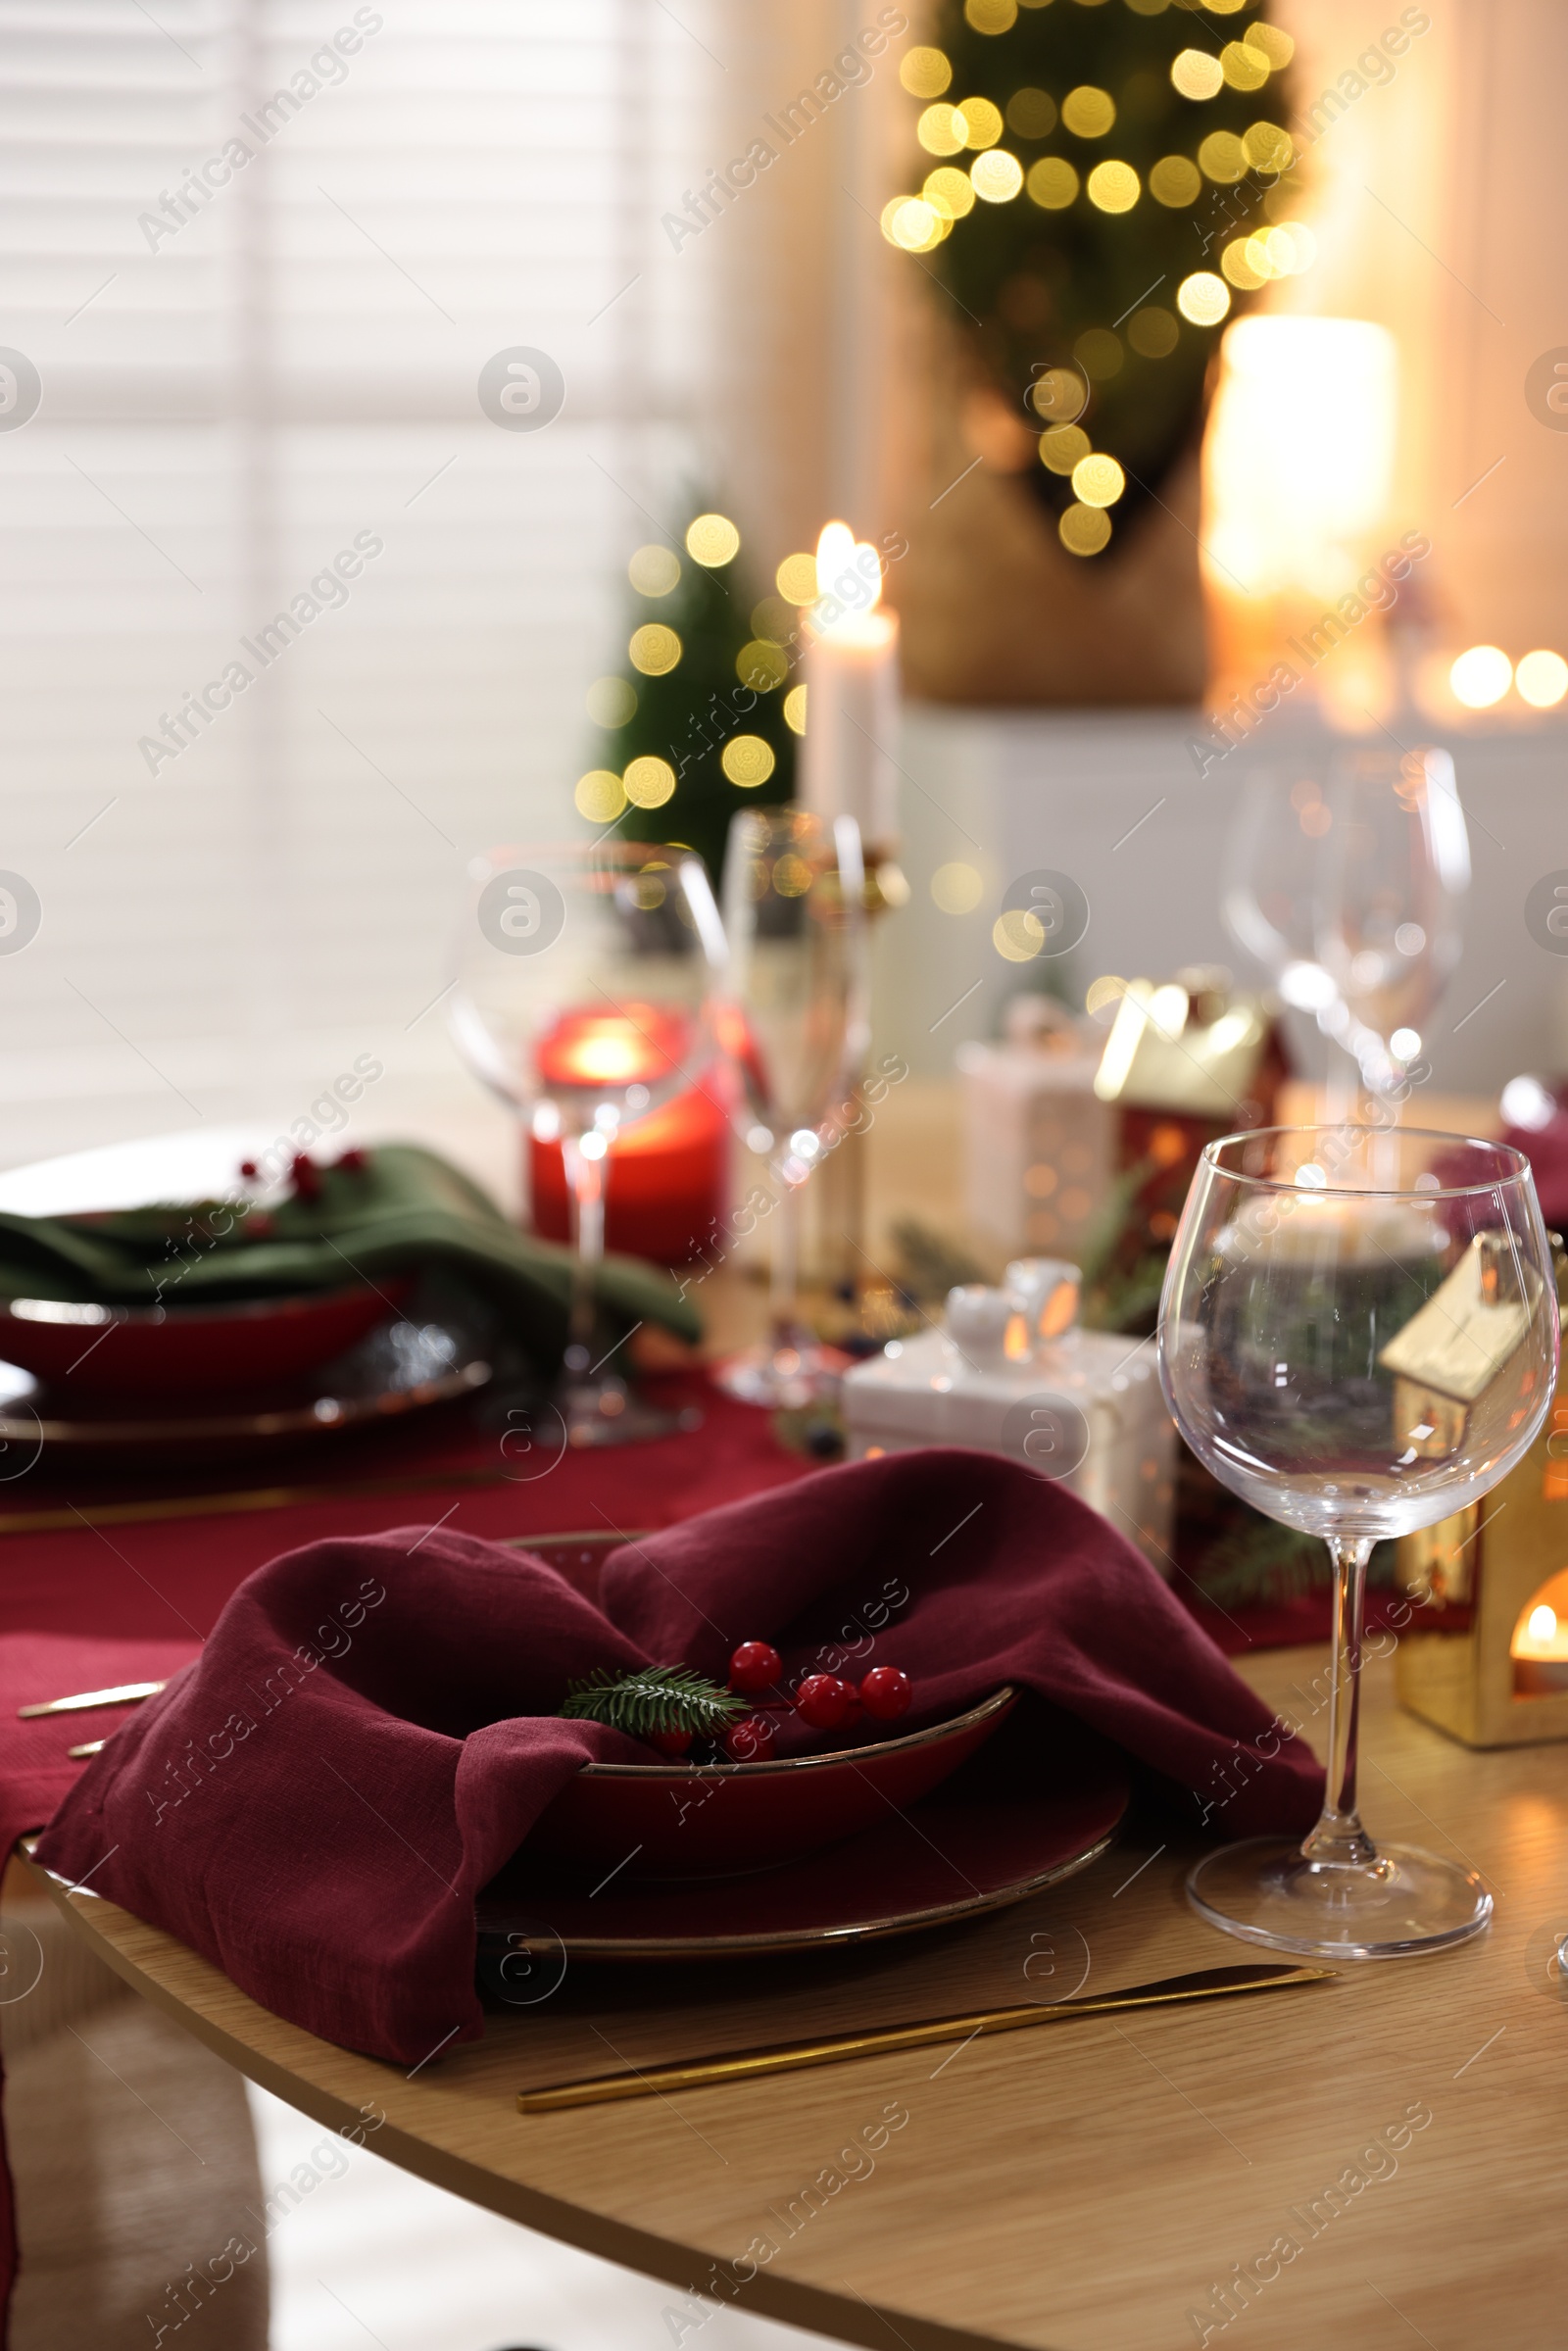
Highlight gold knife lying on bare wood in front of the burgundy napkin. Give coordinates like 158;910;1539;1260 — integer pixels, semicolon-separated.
517;1961;1336;2114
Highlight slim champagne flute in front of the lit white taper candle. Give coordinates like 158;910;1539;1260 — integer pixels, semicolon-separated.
717;808;870;1408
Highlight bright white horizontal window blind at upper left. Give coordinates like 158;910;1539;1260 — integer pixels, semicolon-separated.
0;0;717;1161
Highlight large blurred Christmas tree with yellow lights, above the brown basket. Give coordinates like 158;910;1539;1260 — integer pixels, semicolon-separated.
882;0;1314;555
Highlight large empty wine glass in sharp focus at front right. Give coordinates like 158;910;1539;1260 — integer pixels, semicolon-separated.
1159;1126;1558;1958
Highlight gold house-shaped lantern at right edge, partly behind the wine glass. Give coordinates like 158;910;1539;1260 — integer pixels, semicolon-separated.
1382;1234;1568;1746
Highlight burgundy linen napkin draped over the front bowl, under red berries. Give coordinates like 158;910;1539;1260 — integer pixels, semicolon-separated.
40;1448;1321;2064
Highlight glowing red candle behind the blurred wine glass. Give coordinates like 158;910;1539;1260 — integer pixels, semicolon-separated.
529;1004;729;1265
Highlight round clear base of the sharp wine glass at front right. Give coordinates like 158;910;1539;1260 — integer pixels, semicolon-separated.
1187;1837;1493;1958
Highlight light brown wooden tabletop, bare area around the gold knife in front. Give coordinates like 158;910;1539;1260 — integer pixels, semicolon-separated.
24;1650;1568;2351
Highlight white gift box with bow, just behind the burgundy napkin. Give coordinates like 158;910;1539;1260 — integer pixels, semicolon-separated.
844;1260;1175;1575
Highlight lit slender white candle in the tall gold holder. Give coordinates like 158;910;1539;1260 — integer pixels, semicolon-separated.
802;522;898;854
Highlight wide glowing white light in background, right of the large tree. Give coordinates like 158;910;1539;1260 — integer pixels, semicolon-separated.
1203;315;1396;605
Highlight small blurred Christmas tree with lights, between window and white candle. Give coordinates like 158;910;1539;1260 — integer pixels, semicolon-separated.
576;513;815;884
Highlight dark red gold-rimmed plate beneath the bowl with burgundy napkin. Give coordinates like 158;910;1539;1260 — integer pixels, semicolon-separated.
479;1704;1128;1965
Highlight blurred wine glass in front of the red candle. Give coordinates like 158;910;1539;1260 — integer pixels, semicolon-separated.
449;839;726;1445
